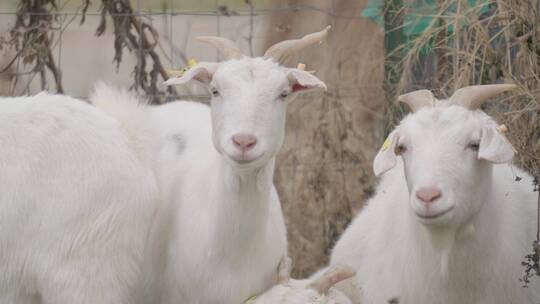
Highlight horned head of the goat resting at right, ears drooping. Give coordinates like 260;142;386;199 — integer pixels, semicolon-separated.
373;84;515;227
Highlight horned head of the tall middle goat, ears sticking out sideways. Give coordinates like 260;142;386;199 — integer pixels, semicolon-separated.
165;27;329;168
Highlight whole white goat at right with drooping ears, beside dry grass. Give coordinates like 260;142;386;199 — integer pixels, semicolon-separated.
331;85;540;304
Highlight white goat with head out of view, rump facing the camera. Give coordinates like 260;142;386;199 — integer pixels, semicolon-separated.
0;93;159;304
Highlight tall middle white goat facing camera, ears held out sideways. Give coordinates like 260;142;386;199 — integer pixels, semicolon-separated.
135;29;328;304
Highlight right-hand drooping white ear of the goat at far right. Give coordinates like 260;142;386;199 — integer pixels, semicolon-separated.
478;126;514;164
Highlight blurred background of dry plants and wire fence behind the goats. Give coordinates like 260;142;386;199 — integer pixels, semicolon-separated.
0;0;540;277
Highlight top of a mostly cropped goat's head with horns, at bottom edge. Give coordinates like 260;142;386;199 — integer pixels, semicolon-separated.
251;257;355;304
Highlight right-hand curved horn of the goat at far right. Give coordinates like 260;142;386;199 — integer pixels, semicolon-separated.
449;84;517;110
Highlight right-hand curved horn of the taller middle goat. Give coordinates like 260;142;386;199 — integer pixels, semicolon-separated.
264;25;331;63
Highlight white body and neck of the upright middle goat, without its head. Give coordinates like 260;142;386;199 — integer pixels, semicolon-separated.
141;102;286;303
